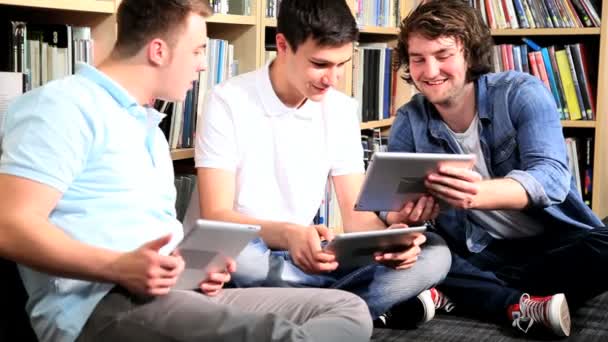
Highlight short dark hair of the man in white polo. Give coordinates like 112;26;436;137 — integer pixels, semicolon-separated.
277;0;359;52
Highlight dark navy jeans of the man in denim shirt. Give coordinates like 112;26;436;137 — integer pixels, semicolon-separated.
438;227;608;321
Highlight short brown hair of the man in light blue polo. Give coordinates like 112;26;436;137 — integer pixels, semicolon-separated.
114;0;213;57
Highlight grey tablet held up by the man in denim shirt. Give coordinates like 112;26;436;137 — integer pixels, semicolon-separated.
355;152;475;211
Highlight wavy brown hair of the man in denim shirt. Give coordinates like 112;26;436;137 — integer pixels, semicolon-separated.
394;0;494;83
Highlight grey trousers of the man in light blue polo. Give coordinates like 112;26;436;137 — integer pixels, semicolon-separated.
77;287;372;342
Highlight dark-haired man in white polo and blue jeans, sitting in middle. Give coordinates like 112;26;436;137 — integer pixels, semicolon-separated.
195;0;451;326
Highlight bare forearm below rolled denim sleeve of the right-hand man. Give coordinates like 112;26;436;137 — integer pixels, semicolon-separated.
475;178;529;210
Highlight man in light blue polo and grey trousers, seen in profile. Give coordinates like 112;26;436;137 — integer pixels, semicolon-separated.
0;0;372;342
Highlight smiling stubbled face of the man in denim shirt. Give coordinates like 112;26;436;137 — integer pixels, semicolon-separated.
408;34;468;106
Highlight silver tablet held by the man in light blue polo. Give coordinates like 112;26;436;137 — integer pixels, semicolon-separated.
173;219;260;290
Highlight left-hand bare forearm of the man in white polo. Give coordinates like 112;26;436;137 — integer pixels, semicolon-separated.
203;210;294;250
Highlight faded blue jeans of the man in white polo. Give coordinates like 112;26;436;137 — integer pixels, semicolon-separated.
232;232;451;319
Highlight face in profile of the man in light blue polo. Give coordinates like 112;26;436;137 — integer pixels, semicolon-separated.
161;13;207;101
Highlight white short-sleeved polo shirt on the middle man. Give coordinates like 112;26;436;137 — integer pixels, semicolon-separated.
195;64;364;225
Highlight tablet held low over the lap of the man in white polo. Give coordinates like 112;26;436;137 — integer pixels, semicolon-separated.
325;225;426;268
